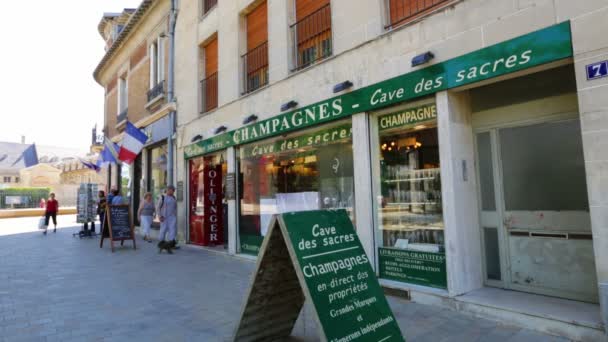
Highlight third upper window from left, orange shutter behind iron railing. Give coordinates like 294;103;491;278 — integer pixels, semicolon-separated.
291;0;332;70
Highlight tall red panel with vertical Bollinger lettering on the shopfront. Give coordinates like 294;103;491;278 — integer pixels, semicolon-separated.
189;152;228;249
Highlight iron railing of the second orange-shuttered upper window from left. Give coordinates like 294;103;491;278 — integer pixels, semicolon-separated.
241;41;268;94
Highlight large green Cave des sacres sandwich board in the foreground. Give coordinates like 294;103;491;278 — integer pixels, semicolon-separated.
234;209;405;342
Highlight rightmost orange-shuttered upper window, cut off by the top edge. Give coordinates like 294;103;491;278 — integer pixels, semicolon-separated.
386;0;454;29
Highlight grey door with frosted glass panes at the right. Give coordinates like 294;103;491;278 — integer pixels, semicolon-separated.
476;118;597;302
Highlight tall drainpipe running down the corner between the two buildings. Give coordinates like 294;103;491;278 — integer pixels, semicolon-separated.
167;0;177;186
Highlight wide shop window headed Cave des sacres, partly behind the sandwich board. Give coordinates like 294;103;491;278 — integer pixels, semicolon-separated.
239;121;354;255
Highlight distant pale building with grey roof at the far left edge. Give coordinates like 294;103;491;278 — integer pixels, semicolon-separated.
0;142;38;188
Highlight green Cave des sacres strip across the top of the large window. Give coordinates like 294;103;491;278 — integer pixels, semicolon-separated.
241;124;353;158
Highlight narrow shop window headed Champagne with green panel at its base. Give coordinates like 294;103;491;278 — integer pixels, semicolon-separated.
373;104;446;288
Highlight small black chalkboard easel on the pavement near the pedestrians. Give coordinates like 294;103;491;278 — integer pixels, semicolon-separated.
99;204;136;252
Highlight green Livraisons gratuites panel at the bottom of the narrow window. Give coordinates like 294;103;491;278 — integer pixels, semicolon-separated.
378;247;448;289
